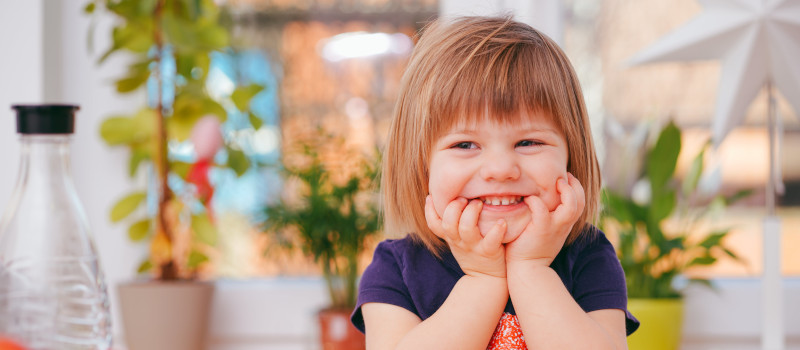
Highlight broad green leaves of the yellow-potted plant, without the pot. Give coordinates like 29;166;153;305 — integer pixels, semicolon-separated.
601;122;749;298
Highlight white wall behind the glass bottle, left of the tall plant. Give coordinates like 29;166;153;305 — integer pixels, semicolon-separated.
0;0;144;340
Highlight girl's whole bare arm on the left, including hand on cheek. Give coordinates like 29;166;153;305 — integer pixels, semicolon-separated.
362;196;508;350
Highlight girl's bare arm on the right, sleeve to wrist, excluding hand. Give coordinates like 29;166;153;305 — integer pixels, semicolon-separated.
508;262;628;349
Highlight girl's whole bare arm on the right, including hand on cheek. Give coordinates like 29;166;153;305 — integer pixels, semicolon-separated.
506;174;627;349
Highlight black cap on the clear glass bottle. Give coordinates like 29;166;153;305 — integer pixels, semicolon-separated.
11;104;80;134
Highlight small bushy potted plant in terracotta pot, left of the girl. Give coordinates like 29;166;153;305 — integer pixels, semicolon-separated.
264;134;380;350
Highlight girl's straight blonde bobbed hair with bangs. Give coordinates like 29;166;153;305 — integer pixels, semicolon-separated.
381;17;600;256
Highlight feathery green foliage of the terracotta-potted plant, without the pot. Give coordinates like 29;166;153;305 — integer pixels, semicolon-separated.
264;136;380;309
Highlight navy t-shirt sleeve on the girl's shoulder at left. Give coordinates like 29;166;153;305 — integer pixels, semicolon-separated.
350;240;418;332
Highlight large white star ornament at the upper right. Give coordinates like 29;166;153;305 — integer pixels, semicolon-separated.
630;0;800;146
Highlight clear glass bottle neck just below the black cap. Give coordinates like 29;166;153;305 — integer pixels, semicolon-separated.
19;134;71;184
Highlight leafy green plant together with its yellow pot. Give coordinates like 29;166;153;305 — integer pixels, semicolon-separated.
600;122;749;350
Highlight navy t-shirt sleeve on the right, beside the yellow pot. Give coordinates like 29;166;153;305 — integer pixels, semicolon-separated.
572;232;639;335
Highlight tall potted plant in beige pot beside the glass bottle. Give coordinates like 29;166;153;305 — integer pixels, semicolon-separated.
85;0;262;350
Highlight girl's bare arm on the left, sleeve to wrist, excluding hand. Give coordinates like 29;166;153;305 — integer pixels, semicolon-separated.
361;275;508;350
